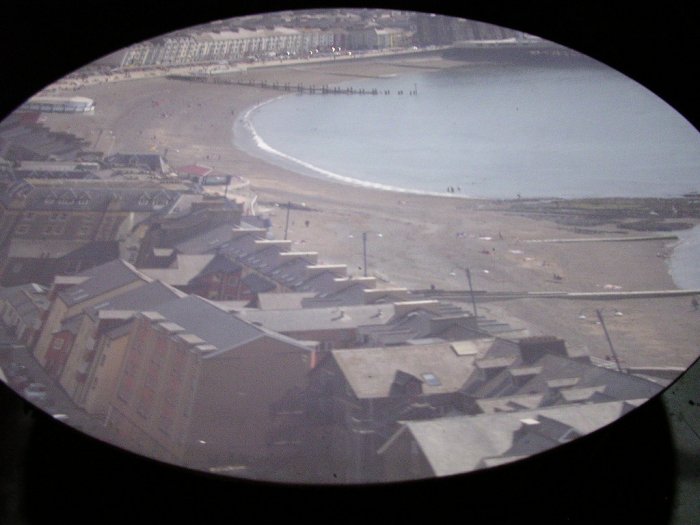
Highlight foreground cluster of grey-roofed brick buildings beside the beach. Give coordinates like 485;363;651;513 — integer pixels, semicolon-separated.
0;170;661;482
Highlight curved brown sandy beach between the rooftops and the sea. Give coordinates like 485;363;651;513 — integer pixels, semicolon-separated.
46;55;700;367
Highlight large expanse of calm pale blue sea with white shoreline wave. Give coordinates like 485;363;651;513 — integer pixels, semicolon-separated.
234;61;700;285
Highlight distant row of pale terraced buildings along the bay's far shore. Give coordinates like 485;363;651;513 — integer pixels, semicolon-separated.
106;12;521;68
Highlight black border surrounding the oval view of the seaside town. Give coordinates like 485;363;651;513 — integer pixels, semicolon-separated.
0;0;700;524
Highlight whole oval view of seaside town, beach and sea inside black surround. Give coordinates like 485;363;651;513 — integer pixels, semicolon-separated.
0;5;700;496
